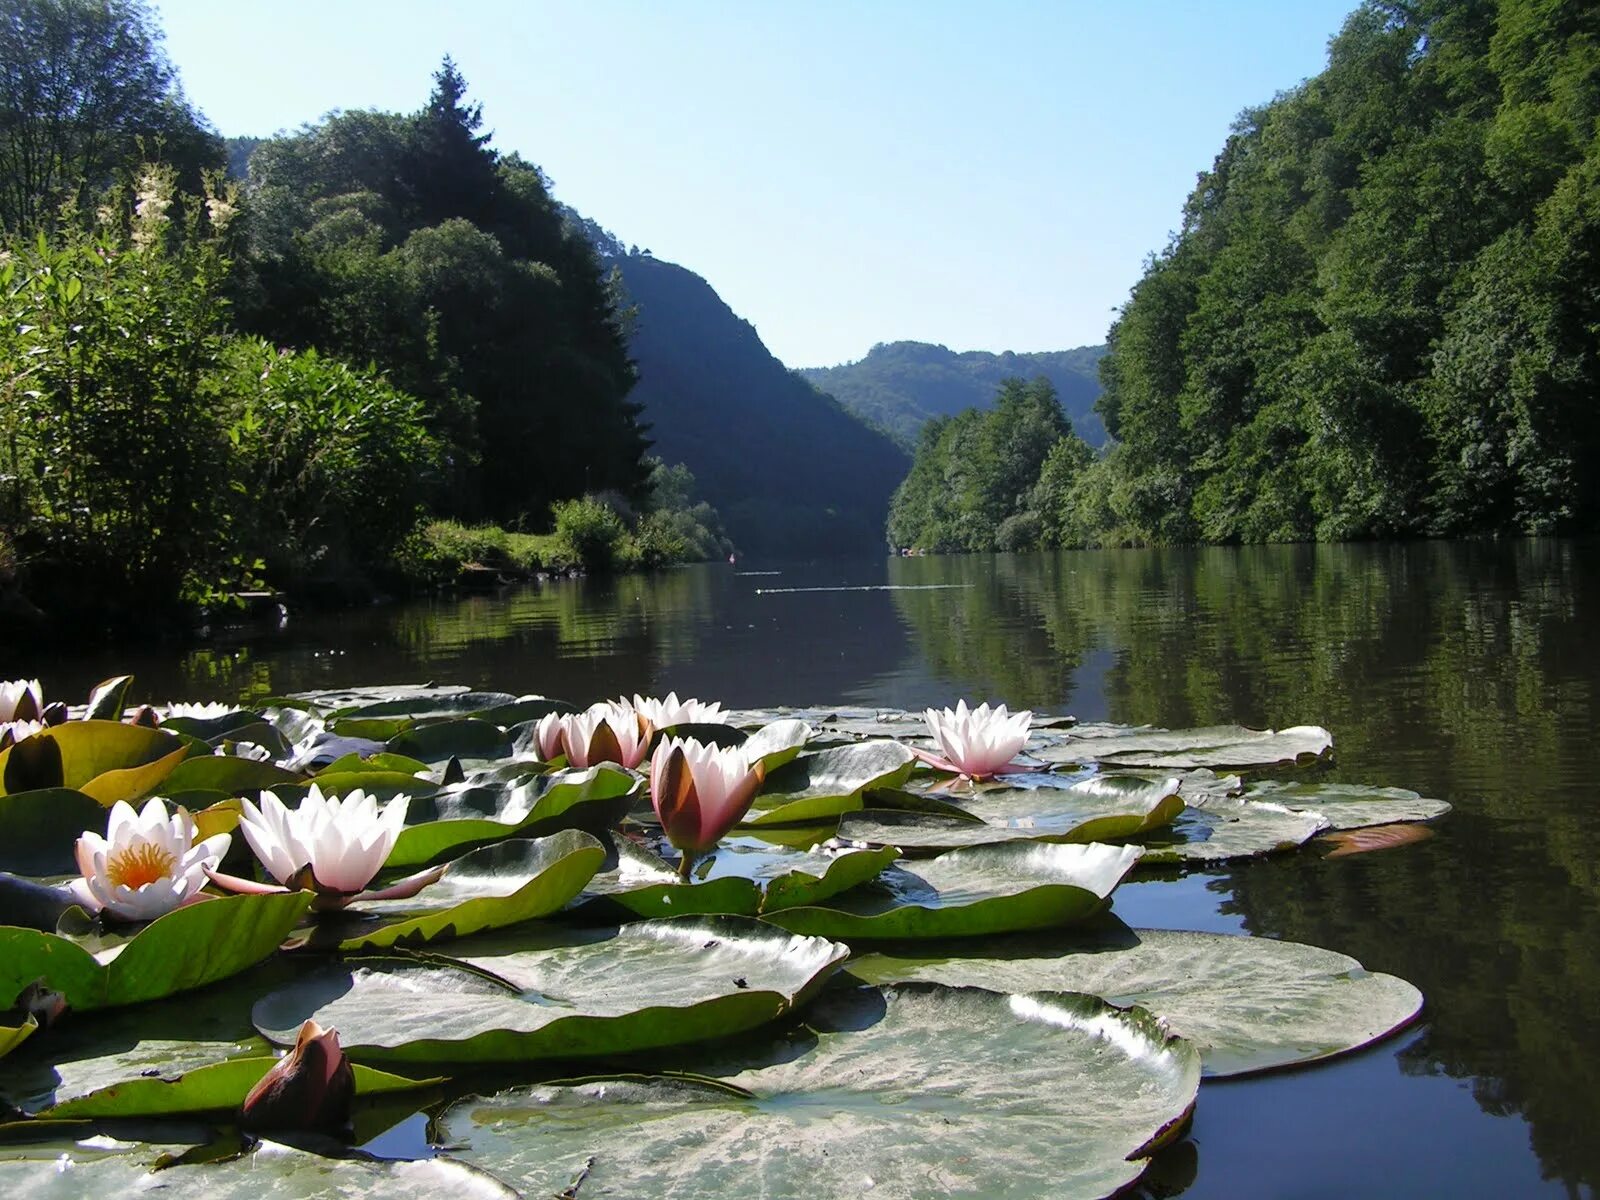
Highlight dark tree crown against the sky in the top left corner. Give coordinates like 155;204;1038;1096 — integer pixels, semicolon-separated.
0;0;222;234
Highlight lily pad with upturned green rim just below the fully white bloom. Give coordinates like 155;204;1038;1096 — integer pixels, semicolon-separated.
339;829;605;950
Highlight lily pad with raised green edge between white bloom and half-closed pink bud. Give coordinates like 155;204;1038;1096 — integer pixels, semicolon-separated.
384;766;643;869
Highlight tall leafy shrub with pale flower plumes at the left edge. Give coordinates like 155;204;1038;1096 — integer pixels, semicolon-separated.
0;170;240;614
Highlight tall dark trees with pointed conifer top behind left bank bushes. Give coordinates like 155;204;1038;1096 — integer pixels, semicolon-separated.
238;59;645;523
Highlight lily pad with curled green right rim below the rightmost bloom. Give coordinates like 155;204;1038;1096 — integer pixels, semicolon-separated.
838;774;1184;853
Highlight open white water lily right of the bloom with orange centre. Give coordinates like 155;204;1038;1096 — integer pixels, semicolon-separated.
238;784;411;896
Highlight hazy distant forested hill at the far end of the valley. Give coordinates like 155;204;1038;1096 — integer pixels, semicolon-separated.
800;342;1106;448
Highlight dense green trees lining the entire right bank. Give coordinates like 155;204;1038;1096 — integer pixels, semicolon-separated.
890;0;1600;549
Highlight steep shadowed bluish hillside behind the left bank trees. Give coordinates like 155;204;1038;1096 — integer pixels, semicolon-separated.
611;253;910;554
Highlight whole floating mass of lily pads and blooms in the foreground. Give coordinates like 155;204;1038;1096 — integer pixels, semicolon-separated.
0;677;1448;1197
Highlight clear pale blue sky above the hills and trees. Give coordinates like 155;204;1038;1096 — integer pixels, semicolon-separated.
155;0;1355;366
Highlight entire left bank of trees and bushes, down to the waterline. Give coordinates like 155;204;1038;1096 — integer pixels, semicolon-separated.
0;0;726;633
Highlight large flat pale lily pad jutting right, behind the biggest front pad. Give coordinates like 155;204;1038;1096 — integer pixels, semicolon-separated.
850;922;1422;1077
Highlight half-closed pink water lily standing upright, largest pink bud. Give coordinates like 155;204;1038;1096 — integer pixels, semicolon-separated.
650;738;766;878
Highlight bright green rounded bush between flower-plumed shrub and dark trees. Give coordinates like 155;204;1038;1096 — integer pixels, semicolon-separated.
210;338;440;579
